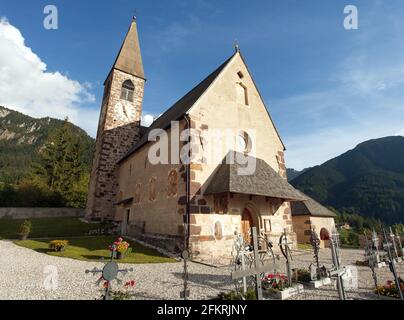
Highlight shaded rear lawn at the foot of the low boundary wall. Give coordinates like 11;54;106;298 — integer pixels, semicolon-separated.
0;218;112;239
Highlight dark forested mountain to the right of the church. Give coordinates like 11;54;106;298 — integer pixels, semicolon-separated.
291;136;404;223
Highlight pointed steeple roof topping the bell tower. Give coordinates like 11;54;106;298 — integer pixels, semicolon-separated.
112;18;144;79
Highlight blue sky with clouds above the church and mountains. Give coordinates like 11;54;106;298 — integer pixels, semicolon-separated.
0;0;404;169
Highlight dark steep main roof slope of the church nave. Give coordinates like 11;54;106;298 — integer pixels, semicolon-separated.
118;52;237;163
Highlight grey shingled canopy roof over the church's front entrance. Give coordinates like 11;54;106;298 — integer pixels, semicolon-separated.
204;156;307;201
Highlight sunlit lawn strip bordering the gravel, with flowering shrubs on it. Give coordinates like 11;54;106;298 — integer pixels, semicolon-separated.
15;236;176;264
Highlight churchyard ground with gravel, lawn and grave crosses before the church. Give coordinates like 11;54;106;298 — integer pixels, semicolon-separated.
0;216;404;301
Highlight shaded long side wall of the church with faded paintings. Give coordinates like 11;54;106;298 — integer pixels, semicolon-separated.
115;123;186;238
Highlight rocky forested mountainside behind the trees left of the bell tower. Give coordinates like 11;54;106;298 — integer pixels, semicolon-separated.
0;106;94;184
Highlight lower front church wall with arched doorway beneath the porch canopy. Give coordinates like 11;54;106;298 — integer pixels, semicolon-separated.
190;193;296;266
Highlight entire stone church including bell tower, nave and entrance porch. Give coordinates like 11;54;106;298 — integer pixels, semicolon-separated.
86;19;334;263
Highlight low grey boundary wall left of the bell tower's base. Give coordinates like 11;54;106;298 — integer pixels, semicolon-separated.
0;208;85;219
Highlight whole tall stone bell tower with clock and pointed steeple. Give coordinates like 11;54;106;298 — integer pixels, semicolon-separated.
86;18;146;221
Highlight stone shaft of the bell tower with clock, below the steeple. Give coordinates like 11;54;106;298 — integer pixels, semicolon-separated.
86;70;144;220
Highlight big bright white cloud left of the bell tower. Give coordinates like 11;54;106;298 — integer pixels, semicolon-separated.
0;18;99;136
